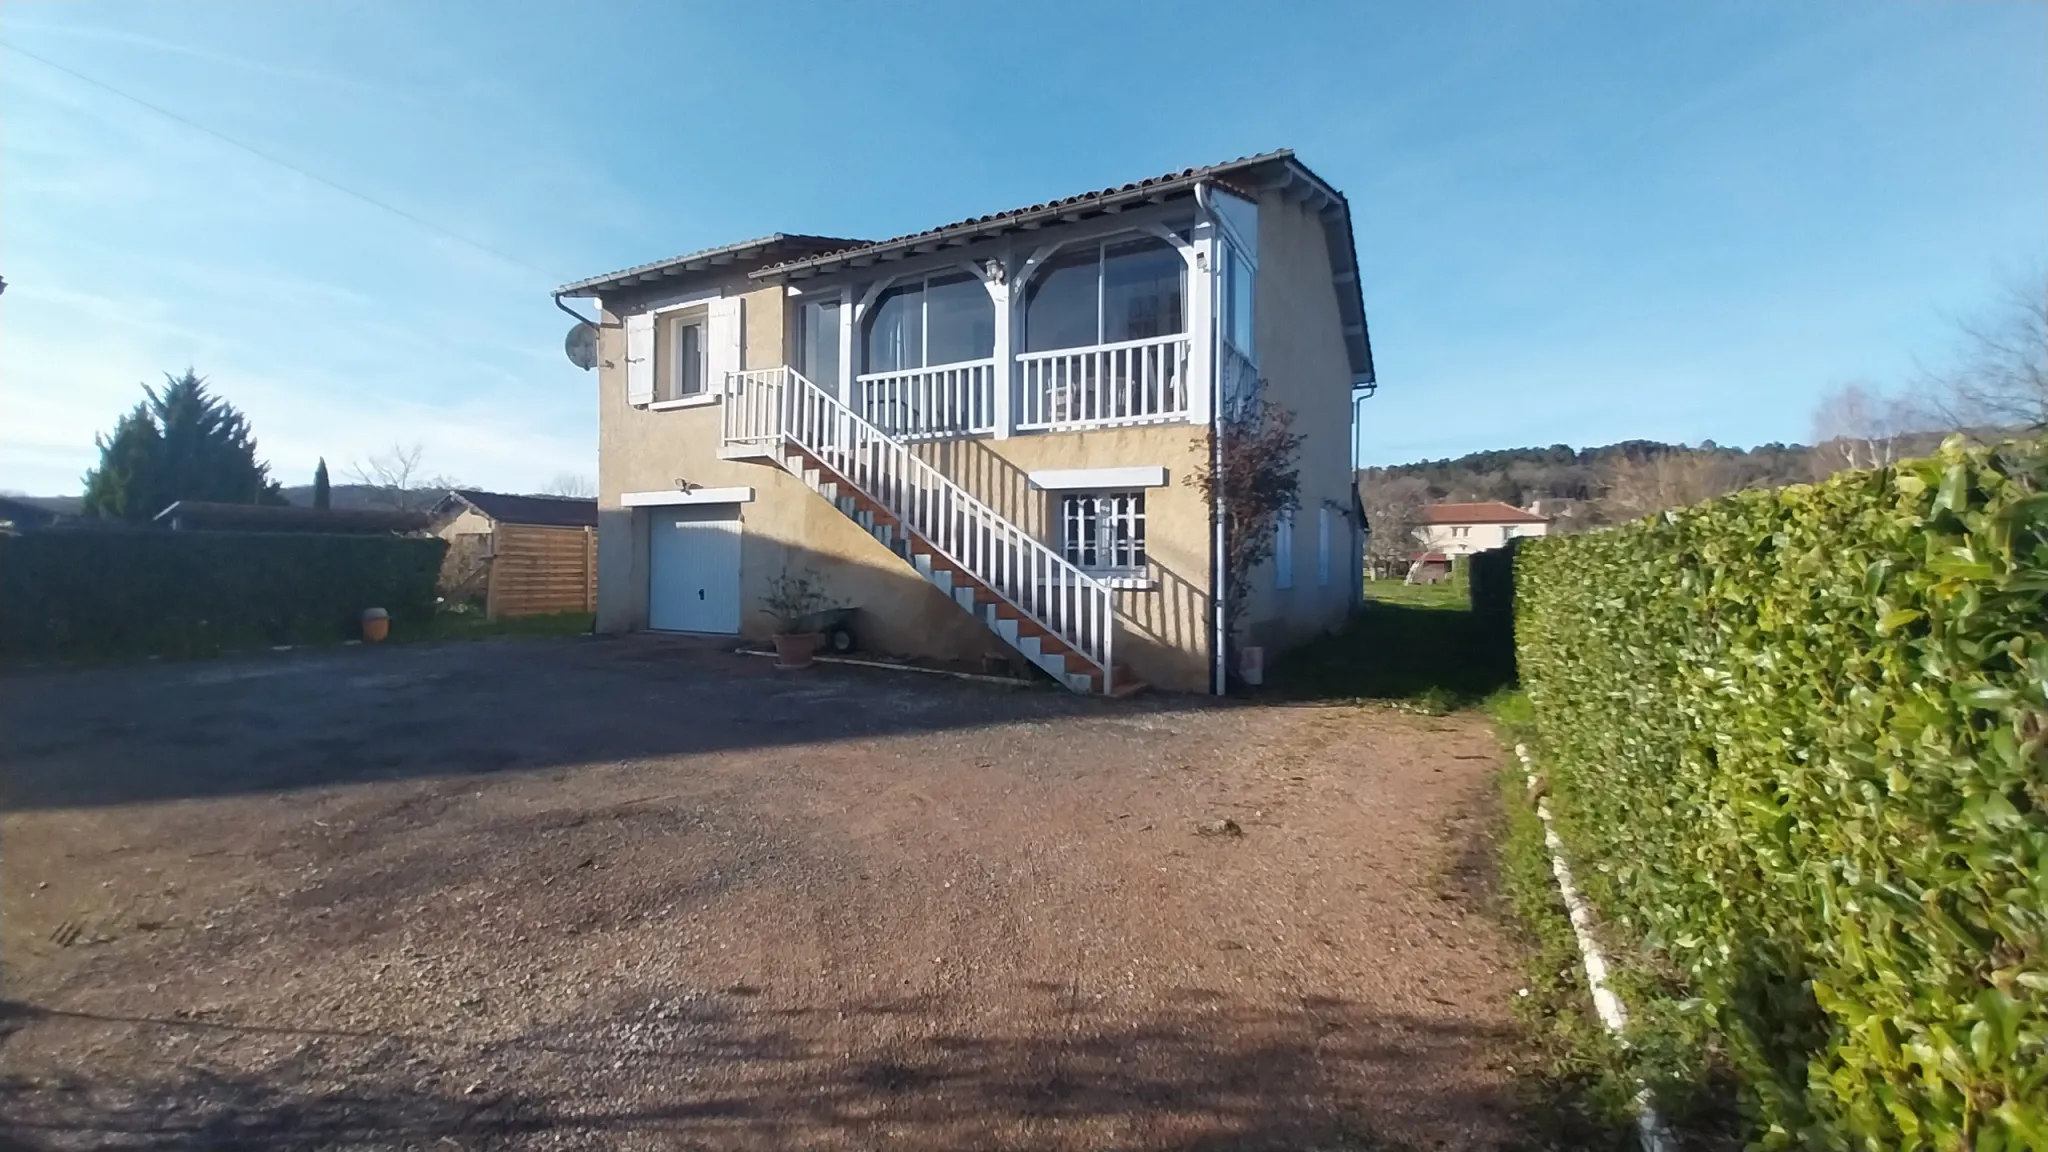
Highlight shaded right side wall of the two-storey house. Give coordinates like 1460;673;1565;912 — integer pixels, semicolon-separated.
1235;193;1362;654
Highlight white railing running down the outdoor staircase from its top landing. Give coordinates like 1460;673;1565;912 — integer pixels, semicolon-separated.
725;367;1116;693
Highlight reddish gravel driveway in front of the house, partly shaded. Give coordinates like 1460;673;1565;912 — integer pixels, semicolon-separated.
0;637;1518;1152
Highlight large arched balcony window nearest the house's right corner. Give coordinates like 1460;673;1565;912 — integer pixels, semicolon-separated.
1024;236;1188;353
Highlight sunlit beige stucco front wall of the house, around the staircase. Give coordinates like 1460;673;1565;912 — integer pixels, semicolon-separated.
598;279;1208;691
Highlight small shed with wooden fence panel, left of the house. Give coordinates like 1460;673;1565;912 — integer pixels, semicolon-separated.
430;488;598;619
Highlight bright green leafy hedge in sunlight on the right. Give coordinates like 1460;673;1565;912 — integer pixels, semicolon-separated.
1516;434;2048;1150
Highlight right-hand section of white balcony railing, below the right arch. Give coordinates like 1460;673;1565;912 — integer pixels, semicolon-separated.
1016;332;1188;430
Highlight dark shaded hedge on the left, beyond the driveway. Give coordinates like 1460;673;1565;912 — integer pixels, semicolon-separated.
0;529;449;658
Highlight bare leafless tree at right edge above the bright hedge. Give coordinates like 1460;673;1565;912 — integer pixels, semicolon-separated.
1923;273;2048;430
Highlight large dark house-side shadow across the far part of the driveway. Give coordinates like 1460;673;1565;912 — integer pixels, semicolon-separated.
0;635;1212;812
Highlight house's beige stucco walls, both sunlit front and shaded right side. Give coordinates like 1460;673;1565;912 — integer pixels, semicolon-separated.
598;195;1360;691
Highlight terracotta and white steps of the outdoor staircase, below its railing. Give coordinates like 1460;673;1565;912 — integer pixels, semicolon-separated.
778;445;1149;697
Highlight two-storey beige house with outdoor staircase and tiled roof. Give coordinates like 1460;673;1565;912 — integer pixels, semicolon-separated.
557;152;1372;691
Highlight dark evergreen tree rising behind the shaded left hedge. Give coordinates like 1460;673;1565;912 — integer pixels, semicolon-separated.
84;369;285;523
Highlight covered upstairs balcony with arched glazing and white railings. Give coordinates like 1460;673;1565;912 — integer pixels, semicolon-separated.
795;223;1208;441
